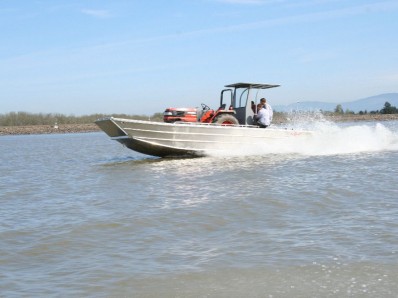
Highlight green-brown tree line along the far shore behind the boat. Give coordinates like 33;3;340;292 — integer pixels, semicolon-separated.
0;102;398;126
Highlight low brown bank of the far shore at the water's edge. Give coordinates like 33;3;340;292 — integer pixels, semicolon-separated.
0;114;398;136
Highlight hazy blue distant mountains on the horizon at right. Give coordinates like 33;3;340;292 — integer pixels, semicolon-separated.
272;93;398;113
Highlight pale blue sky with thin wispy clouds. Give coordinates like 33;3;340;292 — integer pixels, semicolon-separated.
0;0;398;115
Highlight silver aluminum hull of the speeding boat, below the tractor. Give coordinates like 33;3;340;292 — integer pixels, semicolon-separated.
95;117;311;157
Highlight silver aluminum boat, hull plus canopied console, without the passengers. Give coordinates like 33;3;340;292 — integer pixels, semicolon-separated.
95;83;311;157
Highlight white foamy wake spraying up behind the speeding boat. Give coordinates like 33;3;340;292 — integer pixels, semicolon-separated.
208;119;398;156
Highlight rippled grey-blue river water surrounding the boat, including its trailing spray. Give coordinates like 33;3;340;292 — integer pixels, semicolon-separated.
0;121;398;297
